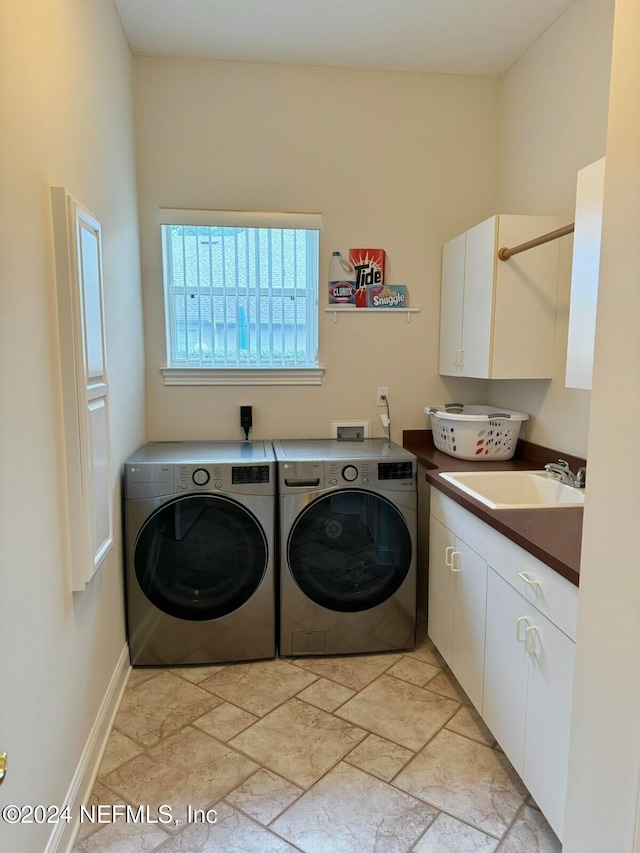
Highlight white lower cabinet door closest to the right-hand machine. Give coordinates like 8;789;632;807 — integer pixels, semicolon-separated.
427;516;456;666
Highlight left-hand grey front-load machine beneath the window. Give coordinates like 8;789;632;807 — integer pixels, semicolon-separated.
124;441;276;666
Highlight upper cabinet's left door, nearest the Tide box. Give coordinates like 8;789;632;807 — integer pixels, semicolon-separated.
439;234;466;376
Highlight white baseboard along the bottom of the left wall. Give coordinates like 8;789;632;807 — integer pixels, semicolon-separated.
44;646;131;853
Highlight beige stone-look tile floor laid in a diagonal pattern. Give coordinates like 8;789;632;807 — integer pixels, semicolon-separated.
75;623;561;853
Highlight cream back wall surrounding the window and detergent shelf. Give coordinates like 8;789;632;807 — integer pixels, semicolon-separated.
135;58;498;440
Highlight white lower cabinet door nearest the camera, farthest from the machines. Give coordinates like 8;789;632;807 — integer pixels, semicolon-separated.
523;610;575;840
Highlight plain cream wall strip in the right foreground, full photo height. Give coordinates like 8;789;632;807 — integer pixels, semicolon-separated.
564;0;640;853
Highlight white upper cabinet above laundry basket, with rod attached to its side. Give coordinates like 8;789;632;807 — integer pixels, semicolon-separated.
439;214;559;379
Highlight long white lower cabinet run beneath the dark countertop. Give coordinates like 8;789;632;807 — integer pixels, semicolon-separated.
429;489;578;840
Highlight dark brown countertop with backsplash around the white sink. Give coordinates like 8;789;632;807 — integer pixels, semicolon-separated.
402;430;586;586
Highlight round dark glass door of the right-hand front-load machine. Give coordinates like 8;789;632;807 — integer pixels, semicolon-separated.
287;489;411;613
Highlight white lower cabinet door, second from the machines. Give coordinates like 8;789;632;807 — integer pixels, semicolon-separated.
452;538;487;710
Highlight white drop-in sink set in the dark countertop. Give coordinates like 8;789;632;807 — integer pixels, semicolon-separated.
439;471;585;509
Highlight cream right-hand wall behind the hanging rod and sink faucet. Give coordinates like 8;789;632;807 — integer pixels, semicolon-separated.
489;0;614;456
